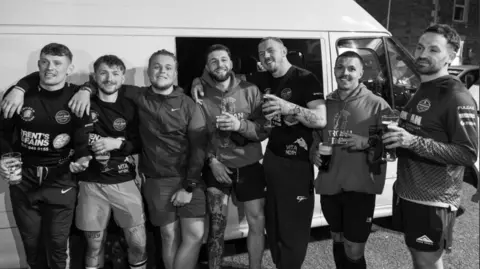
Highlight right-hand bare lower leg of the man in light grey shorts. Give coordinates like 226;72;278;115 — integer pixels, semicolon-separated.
123;224;147;269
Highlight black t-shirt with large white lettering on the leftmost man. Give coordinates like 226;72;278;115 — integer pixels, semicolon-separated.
0;84;92;187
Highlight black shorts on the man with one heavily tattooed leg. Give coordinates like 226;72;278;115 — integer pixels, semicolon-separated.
202;162;266;202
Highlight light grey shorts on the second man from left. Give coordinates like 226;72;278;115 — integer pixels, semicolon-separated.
75;180;145;232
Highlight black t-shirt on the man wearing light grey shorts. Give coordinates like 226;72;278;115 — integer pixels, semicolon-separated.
79;87;141;184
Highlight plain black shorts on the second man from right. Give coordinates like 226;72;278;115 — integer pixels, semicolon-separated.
320;191;376;243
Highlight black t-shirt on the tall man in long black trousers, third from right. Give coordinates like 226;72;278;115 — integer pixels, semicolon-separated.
248;66;324;161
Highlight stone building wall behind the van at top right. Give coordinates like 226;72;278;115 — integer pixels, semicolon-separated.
356;0;480;64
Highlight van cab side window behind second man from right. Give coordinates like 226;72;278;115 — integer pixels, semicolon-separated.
337;38;392;105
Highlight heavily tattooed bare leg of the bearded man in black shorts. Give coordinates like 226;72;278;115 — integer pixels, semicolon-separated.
207;187;228;269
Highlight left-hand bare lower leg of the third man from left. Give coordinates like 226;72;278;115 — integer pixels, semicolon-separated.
160;220;180;269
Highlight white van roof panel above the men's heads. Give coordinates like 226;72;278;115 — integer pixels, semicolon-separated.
0;0;388;35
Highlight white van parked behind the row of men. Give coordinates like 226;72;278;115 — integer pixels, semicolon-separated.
0;0;419;268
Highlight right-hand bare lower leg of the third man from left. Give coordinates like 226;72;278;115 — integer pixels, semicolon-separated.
174;217;205;269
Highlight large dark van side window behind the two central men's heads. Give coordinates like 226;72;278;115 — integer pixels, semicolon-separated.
175;37;323;94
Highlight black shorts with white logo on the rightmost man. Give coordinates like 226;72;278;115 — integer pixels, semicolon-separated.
393;191;456;252
